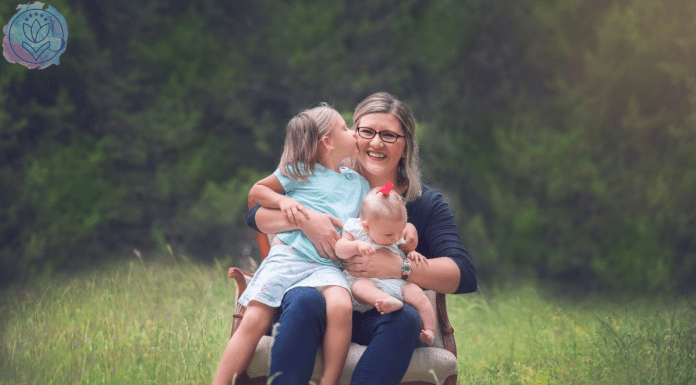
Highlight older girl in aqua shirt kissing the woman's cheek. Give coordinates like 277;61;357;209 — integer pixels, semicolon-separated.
213;104;370;385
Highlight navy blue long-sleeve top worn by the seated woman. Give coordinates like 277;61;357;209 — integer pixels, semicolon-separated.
247;184;478;294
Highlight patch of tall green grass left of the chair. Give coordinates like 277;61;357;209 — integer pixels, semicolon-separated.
0;254;234;385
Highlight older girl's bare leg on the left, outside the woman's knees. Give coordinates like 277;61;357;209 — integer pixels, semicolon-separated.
213;301;276;385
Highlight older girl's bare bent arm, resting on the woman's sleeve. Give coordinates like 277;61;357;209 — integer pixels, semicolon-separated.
249;174;309;226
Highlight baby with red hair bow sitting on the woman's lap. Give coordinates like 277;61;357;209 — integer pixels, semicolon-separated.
335;183;435;345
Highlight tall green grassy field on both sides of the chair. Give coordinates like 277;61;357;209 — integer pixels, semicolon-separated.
0;257;696;385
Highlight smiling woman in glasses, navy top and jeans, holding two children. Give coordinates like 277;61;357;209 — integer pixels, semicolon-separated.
247;93;477;385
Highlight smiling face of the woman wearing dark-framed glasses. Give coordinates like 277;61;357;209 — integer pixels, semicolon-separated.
356;113;406;181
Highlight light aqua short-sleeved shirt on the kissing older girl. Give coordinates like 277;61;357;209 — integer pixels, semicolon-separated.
273;164;370;265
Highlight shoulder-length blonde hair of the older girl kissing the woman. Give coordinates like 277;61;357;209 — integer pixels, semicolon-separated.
278;103;341;181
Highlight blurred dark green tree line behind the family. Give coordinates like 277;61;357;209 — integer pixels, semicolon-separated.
0;0;696;291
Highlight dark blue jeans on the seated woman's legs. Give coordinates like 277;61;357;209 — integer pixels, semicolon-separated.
270;287;422;385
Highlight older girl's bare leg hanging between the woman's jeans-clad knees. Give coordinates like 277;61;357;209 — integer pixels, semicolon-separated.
319;286;353;385
